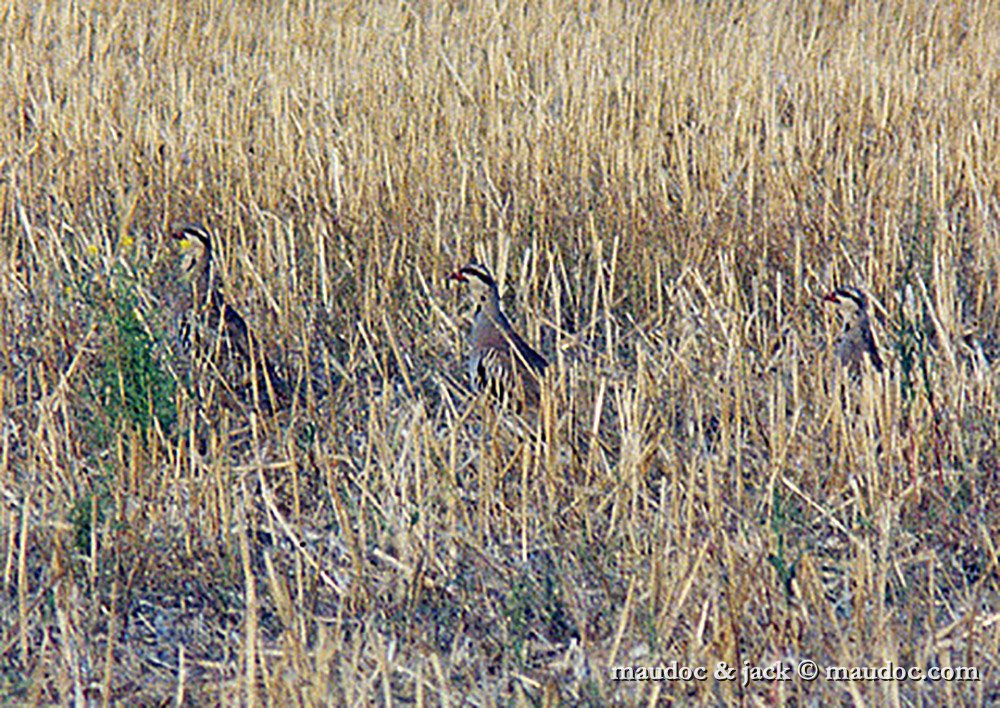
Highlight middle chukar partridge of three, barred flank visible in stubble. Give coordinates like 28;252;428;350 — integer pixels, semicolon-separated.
448;263;548;406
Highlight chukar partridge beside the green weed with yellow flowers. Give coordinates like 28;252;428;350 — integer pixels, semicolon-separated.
172;224;290;413
